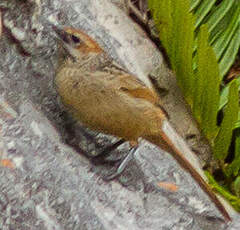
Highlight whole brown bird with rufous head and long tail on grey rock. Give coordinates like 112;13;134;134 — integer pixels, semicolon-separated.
53;26;231;221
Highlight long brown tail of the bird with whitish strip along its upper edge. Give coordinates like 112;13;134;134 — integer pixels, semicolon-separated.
145;119;231;221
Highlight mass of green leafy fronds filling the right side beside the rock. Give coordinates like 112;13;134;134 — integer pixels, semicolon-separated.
148;0;240;210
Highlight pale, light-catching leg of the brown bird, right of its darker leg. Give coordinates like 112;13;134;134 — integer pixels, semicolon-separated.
103;143;138;181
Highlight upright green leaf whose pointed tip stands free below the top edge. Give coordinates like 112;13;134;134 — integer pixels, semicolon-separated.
193;25;220;142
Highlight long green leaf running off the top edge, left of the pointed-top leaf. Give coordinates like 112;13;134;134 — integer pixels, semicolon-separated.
171;0;194;104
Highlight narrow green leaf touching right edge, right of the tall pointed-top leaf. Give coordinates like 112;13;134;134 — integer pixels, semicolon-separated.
213;80;239;160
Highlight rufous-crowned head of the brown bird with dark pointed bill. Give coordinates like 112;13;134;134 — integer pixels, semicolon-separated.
52;25;103;58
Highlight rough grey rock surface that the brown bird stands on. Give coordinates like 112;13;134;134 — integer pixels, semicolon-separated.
0;0;239;230
